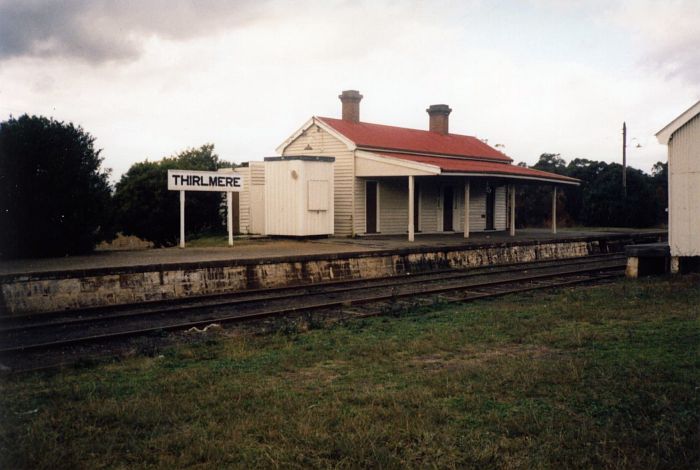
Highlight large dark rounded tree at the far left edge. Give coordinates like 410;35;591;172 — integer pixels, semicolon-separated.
0;114;111;258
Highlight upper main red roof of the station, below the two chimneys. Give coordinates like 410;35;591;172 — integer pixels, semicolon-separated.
318;117;513;162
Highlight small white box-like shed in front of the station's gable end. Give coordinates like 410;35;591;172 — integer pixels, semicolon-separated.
265;156;334;236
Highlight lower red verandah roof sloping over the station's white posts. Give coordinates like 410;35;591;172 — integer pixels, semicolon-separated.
376;152;579;183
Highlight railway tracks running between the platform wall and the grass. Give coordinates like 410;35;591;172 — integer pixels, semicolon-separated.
0;255;625;370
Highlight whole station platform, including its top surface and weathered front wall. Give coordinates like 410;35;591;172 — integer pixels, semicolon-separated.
0;230;666;315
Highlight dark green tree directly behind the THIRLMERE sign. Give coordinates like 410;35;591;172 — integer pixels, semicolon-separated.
114;144;231;246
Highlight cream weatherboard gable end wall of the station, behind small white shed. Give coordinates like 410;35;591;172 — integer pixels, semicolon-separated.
282;125;352;236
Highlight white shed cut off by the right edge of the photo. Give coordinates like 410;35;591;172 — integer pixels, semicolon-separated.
656;101;700;271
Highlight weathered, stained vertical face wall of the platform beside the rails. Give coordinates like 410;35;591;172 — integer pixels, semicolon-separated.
0;238;656;315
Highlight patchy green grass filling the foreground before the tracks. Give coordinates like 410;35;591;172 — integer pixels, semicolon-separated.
0;277;700;468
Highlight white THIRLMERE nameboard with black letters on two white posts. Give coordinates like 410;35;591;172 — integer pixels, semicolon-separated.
168;170;243;248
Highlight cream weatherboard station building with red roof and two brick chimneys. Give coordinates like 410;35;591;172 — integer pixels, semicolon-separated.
238;90;579;240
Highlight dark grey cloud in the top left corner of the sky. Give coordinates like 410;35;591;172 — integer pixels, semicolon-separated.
0;0;270;63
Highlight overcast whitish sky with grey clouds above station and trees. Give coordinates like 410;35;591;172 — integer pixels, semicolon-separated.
0;0;700;179
